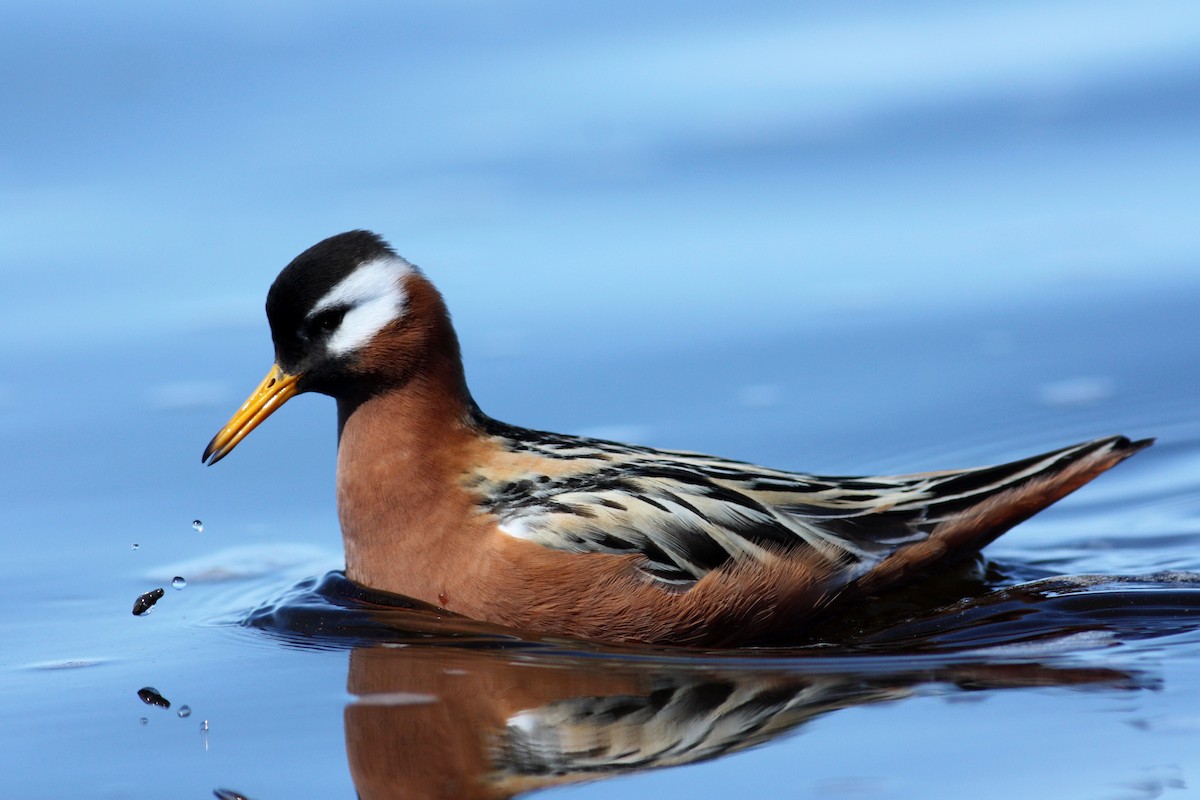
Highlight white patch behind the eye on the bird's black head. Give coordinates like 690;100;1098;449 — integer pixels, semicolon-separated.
308;255;413;355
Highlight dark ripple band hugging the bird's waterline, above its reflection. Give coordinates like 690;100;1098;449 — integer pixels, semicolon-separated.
244;572;1200;666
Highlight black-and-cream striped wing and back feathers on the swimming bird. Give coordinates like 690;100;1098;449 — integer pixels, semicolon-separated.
474;423;1141;587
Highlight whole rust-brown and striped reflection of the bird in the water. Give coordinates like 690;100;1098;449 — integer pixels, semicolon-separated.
346;645;1135;800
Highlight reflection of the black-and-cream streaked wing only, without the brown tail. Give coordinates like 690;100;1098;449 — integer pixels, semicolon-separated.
494;676;908;776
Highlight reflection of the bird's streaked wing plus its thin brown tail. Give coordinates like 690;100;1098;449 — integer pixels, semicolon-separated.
490;662;1136;782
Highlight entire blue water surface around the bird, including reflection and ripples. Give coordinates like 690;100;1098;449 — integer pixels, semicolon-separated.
7;2;1200;800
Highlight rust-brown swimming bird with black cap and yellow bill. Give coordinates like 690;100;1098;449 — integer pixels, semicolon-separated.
203;230;1153;648
